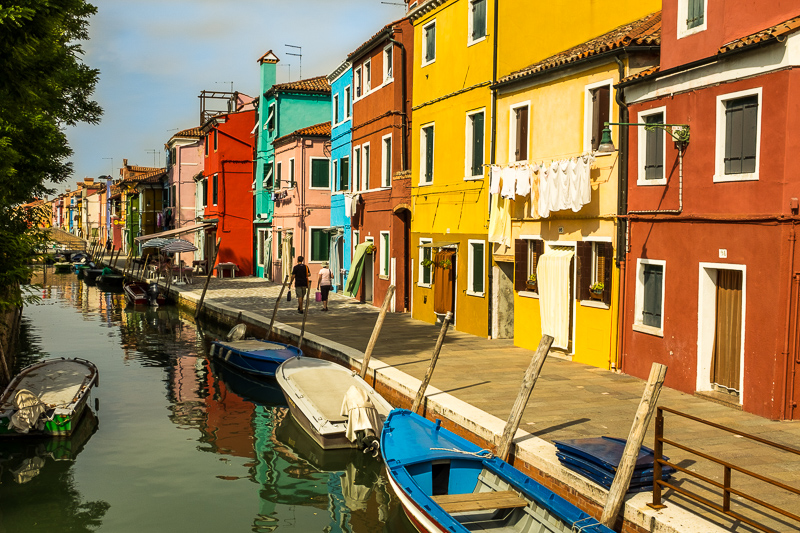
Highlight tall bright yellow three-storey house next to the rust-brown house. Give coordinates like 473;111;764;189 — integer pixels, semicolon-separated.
409;0;494;335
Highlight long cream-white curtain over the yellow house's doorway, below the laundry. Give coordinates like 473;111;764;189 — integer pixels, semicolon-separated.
536;246;575;349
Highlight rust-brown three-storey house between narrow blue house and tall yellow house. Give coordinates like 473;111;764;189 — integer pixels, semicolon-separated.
346;18;414;312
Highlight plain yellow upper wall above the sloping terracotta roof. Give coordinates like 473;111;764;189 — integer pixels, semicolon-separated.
496;0;661;79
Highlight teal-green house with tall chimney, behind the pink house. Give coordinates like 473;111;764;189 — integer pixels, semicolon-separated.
253;50;331;279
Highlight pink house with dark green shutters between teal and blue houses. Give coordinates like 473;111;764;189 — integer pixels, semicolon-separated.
264;122;332;286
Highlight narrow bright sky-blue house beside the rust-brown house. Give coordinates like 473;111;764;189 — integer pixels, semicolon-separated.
328;61;353;292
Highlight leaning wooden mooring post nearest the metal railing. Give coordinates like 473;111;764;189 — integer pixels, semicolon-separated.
600;363;667;527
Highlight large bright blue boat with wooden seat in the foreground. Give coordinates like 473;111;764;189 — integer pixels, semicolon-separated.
381;409;612;533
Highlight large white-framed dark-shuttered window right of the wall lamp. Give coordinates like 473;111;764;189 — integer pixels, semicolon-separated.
714;88;761;181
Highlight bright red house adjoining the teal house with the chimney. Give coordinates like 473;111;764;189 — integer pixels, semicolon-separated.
202;94;256;276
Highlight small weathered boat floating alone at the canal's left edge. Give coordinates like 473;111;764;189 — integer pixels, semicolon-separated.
0;358;97;437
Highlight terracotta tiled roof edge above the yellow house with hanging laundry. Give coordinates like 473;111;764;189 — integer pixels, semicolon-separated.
497;11;661;85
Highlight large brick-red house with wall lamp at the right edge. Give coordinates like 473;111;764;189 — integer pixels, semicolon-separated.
617;0;800;419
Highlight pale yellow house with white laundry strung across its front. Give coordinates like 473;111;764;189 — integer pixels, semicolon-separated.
489;13;661;368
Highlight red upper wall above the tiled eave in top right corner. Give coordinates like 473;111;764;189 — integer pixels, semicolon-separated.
661;0;800;70
